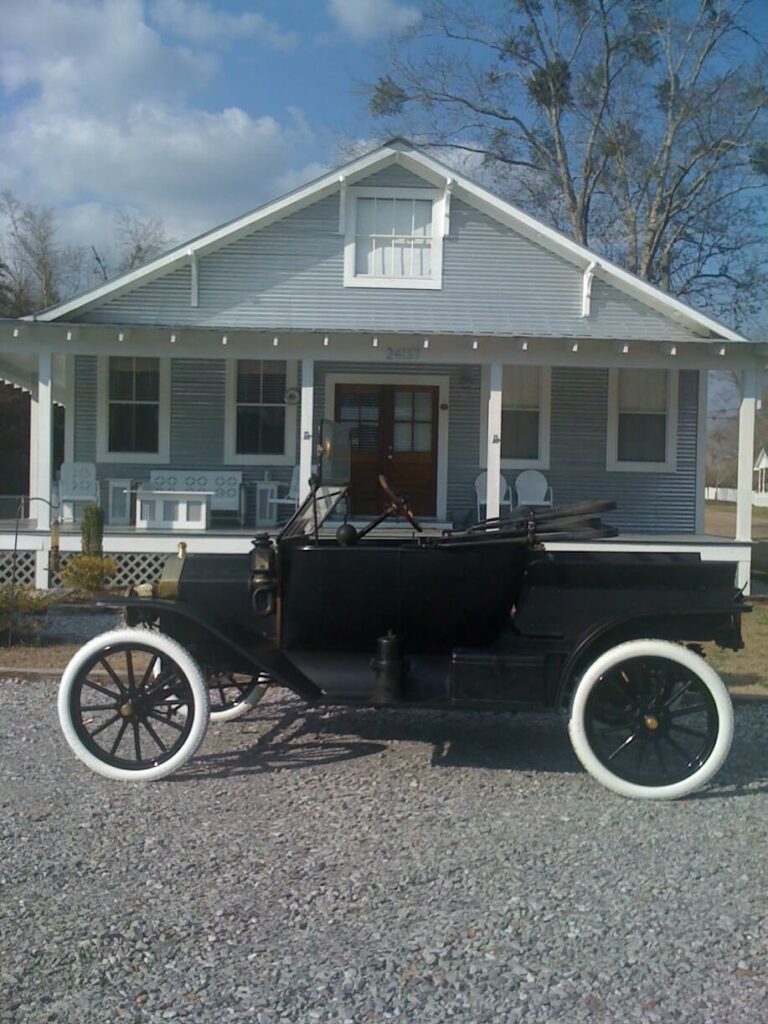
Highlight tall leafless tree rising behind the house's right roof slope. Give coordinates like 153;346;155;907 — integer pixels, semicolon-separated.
370;0;768;323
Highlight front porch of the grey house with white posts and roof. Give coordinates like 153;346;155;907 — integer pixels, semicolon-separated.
0;323;762;586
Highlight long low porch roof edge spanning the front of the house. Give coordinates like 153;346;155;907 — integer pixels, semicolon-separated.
0;321;768;391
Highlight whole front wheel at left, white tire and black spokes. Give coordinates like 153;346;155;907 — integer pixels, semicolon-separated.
58;629;209;780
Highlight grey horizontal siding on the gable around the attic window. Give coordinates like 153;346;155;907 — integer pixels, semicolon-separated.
77;193;695;341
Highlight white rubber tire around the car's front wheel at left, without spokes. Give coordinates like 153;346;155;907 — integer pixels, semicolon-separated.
58;627;210;782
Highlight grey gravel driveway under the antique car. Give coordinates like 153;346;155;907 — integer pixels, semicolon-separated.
0;683;768;1024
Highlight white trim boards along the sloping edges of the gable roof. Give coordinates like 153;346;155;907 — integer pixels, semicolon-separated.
28;138;746;342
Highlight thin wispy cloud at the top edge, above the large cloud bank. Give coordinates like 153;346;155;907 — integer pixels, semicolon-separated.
151;0;298;50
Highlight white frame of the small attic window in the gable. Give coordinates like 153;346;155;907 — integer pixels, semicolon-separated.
340;185;446;289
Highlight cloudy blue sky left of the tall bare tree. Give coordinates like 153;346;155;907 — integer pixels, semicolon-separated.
0;0;420;245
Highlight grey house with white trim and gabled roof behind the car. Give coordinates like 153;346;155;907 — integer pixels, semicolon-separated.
0;139;766;585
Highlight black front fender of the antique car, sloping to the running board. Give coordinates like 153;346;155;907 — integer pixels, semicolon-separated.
110;597;323;705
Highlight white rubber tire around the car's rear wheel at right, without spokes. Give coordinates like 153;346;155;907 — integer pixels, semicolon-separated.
568;640;733;800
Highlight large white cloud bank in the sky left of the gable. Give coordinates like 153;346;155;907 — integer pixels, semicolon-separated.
0;0;322;245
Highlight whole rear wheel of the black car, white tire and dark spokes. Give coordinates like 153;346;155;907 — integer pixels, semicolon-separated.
568;640;733;800
